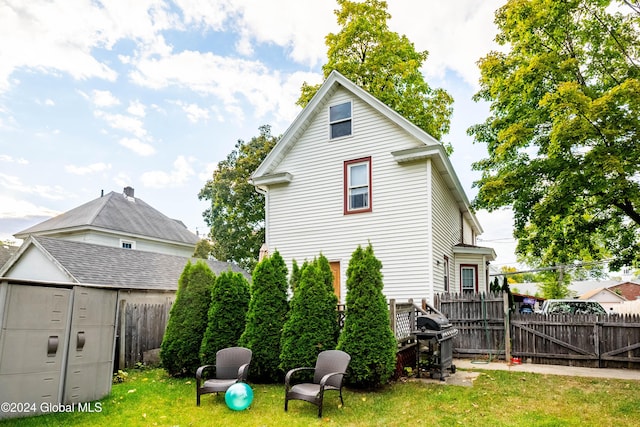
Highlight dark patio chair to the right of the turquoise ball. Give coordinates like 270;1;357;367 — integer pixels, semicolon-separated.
284;350;351;418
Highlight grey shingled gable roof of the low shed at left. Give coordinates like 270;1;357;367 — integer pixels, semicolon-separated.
0;236;251;291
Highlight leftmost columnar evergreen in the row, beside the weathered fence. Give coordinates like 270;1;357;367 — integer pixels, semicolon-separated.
160;260;215;376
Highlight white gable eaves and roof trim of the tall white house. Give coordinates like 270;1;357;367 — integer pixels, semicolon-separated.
251;71;482;234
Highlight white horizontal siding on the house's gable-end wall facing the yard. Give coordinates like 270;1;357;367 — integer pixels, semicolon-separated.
267;89;431;300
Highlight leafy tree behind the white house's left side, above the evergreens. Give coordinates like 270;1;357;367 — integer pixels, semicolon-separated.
198;125;278;271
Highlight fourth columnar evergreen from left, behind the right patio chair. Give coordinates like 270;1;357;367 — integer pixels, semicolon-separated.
280;256;338;372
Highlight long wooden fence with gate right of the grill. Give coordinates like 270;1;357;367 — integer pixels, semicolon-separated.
424;293;640;369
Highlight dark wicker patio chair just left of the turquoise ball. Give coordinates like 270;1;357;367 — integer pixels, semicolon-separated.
196;347;252;406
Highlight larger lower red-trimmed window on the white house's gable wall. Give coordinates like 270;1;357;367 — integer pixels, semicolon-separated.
344;157;371;214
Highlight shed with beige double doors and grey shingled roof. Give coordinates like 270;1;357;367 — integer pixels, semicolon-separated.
0;236;248;418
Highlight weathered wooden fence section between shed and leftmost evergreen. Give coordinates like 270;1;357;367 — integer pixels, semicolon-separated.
116;301;171;369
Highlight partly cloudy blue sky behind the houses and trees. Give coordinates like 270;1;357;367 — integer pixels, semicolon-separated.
0;0;515;265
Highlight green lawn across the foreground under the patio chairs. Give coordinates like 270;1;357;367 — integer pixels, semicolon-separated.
5;369;640;427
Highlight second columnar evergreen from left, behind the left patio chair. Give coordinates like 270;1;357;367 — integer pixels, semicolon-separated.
200;271;251;365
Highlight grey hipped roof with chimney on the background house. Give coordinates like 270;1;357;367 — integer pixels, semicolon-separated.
15;191;198;245
